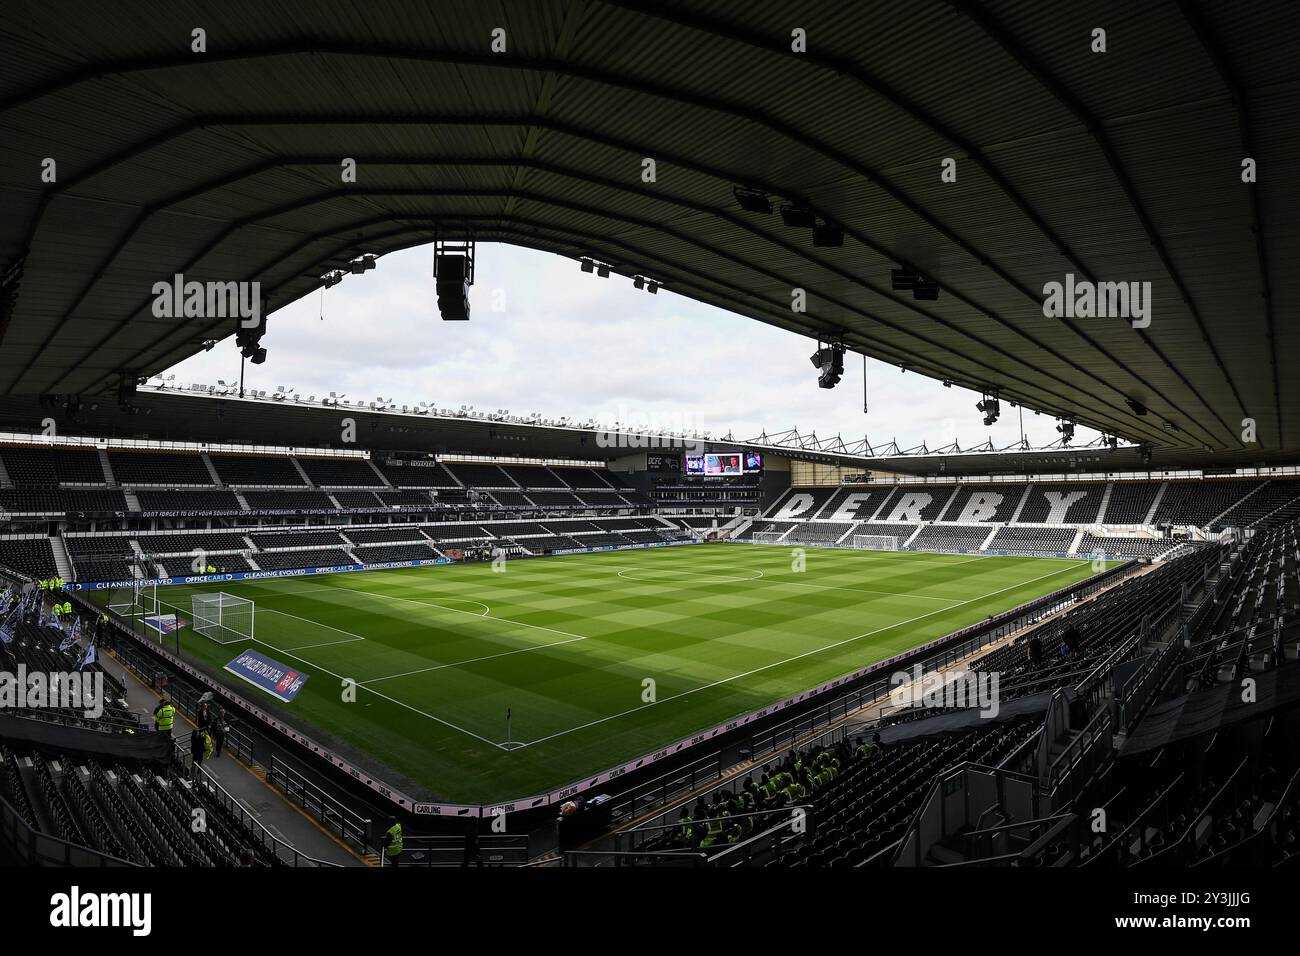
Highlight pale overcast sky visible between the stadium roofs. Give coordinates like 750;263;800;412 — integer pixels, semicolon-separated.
162;243;1095;447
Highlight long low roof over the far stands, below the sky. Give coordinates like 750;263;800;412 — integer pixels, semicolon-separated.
0;385;1300;479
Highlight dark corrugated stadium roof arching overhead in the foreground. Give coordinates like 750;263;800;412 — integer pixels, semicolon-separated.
0;0;1300;458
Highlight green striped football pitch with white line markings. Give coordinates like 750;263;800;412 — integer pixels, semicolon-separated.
104;544;1107;804
